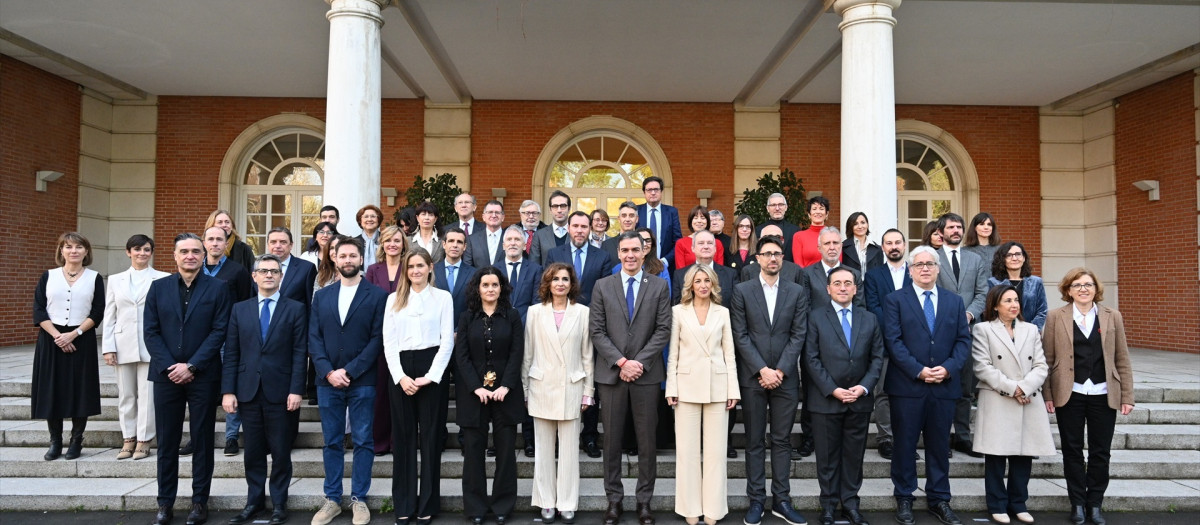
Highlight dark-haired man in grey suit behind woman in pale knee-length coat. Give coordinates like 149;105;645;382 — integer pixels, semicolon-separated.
937;213;991;458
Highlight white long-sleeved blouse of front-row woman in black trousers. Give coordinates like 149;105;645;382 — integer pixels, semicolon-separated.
383;285;454;384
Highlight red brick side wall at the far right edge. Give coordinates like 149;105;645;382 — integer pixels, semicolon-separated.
1116;72;1200;352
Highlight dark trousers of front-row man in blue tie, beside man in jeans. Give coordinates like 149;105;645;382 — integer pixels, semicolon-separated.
238;388;300;508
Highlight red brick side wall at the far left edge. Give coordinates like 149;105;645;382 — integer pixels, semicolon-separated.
0;55;80;346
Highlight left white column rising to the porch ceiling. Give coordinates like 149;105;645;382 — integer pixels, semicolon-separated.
324;0;386;235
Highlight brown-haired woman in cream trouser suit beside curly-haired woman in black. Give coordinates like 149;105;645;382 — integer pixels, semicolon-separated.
521;263;594;524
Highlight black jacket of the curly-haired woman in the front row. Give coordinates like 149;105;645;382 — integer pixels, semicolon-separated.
454;307;526;428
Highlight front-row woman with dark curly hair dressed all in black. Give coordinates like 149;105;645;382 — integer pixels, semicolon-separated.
454;266;525;524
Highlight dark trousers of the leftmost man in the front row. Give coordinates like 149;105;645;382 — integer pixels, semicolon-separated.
154;381;221;507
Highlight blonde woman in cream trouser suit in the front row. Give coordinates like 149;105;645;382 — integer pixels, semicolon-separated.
666;265;742;524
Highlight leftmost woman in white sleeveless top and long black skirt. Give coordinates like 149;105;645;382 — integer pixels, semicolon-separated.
30;231;104;461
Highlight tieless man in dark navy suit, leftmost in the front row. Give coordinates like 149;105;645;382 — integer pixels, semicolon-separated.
144;233;233;524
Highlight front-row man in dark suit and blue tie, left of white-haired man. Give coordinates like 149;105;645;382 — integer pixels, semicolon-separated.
804;266;884;525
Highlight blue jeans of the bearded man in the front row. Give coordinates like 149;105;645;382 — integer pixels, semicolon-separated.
317;385;374;502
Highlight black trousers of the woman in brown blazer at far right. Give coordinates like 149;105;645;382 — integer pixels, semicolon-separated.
1055;393;1117;507
